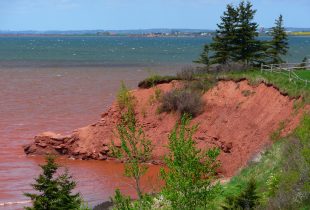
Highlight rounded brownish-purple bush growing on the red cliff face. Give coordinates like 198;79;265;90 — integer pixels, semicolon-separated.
159;89;204;117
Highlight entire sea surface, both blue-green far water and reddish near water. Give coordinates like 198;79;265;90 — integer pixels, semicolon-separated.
0;37;310;210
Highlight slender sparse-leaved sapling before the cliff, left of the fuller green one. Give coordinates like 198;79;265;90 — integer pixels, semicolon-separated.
111;85;153;199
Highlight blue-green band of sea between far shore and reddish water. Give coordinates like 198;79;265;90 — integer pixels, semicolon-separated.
0;37;310;66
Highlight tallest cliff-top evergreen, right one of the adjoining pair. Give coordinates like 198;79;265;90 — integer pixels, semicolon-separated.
233;1;263;65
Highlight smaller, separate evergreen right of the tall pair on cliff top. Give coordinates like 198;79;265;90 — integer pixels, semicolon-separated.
268;15;289;63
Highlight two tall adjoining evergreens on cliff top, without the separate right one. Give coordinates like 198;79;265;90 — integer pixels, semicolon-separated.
206;1;265;65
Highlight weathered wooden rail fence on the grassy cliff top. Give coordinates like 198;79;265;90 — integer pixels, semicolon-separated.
261;62;310;85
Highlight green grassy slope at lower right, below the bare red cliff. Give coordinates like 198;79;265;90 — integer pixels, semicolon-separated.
209;114;310;209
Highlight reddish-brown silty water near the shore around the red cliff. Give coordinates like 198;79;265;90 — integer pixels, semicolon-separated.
0;67;175;210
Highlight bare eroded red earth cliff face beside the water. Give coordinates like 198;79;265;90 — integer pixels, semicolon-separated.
24;81;301;176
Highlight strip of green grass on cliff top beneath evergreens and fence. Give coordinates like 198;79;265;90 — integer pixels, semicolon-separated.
218;70;310;103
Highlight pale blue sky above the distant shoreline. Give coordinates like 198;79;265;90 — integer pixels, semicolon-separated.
0;0;310;31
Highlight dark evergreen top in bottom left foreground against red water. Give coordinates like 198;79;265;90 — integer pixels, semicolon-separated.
25;156;82;210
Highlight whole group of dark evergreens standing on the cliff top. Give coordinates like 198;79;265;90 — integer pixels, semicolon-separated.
195;1;289;66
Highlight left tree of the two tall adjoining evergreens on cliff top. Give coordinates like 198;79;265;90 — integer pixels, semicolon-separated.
210;4;238;64
